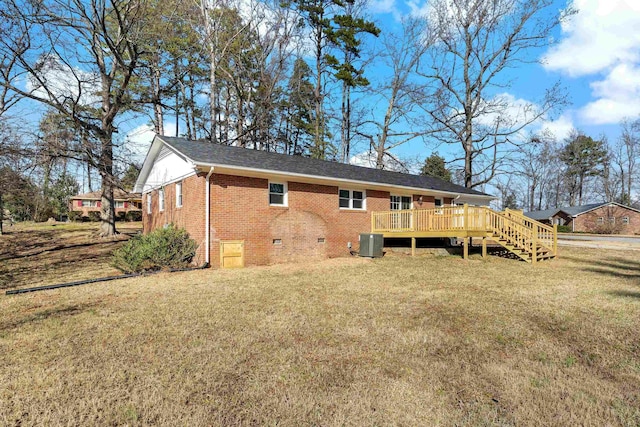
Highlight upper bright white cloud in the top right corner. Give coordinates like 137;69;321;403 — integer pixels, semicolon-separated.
545;0;640;77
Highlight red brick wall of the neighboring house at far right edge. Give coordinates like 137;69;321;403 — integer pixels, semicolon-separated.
574;205;640;234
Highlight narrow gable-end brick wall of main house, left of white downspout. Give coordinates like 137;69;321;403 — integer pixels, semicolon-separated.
142;174;206;265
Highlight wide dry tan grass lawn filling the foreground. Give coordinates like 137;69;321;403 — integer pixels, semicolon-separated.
0;226;640;426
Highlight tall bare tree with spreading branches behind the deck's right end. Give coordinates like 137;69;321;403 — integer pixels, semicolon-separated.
420;0;572;187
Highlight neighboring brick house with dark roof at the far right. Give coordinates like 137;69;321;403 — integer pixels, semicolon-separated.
525;202;640;234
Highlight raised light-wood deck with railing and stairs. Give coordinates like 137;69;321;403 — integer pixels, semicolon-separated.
371;205;558;263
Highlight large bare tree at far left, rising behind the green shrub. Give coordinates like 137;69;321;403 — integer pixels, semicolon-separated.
0;0;146;236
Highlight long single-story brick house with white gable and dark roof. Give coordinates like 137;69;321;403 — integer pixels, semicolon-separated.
134;136;493;267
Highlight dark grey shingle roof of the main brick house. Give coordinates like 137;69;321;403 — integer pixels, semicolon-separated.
158;136;491;197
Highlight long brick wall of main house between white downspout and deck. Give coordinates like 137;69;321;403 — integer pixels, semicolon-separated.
211;174;389;267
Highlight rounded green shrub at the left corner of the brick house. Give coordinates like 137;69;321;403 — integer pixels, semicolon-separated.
111;224;198;273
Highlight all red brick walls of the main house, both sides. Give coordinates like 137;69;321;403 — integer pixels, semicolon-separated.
142;174;472;267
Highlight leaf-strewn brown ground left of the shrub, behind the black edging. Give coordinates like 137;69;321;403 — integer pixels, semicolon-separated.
0;222;142;291
